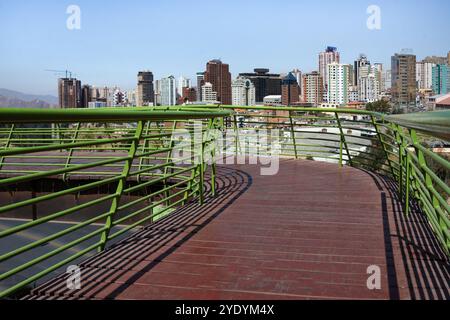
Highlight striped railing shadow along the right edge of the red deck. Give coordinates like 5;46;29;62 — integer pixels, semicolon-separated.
363;170;450;300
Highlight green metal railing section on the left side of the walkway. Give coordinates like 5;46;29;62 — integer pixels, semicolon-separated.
0;109;229;297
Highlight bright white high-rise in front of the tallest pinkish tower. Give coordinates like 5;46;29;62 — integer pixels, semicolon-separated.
327;62;350;105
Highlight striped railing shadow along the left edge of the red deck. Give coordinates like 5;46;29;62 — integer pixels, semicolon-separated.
25;167;252;300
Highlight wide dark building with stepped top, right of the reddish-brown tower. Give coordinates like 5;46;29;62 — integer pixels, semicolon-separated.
239;68;281;103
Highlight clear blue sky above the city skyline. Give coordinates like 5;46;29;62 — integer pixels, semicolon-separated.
0;0;450;94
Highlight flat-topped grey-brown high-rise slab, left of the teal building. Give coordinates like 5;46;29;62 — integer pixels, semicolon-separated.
391;53;417;106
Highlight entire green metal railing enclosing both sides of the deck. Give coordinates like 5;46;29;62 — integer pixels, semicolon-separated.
0;105;450;296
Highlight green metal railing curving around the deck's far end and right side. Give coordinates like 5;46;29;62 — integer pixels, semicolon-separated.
211;106;450;256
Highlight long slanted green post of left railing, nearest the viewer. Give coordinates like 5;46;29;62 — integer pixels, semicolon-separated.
98;121;144;251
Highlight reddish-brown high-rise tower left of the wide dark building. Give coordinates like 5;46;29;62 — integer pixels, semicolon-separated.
205;59;231;105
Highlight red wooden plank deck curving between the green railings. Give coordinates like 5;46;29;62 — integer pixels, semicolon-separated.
27;160;450;299
